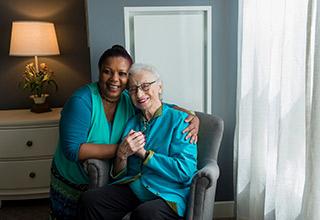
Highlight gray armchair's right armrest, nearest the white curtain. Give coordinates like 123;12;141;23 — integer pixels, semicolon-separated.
186;160;219;220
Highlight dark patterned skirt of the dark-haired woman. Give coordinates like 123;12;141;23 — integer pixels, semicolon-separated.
49;161;88;220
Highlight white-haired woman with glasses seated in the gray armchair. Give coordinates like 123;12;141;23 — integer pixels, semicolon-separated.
79;64;197;220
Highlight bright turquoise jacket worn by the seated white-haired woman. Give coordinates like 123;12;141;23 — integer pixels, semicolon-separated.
111;104;197;216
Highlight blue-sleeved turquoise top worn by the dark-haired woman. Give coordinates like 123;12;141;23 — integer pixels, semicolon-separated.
52;83;135;184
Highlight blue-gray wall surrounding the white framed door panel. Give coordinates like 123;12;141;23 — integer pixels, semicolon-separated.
87;0;238;201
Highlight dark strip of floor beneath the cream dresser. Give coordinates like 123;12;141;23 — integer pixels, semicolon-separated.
0;199;49;220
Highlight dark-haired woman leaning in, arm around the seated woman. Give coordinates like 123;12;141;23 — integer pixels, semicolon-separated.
50;45;198;219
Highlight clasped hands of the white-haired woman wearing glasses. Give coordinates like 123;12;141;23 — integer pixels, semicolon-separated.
117;130;145;160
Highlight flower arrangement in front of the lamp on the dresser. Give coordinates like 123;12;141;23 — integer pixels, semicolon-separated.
20;63;58;97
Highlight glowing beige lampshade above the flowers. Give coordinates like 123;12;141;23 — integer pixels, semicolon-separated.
9;21;60;56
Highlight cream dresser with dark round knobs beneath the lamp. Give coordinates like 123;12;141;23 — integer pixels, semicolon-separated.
0;108;61;207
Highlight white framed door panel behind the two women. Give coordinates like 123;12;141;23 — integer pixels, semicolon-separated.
124;6;212;113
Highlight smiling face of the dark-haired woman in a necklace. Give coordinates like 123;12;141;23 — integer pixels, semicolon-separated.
99;57;130;102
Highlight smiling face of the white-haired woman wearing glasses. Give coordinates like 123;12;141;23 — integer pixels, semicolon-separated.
129;70;162;116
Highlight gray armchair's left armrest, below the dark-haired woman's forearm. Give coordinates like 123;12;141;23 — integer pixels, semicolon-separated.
84;159;110;189
